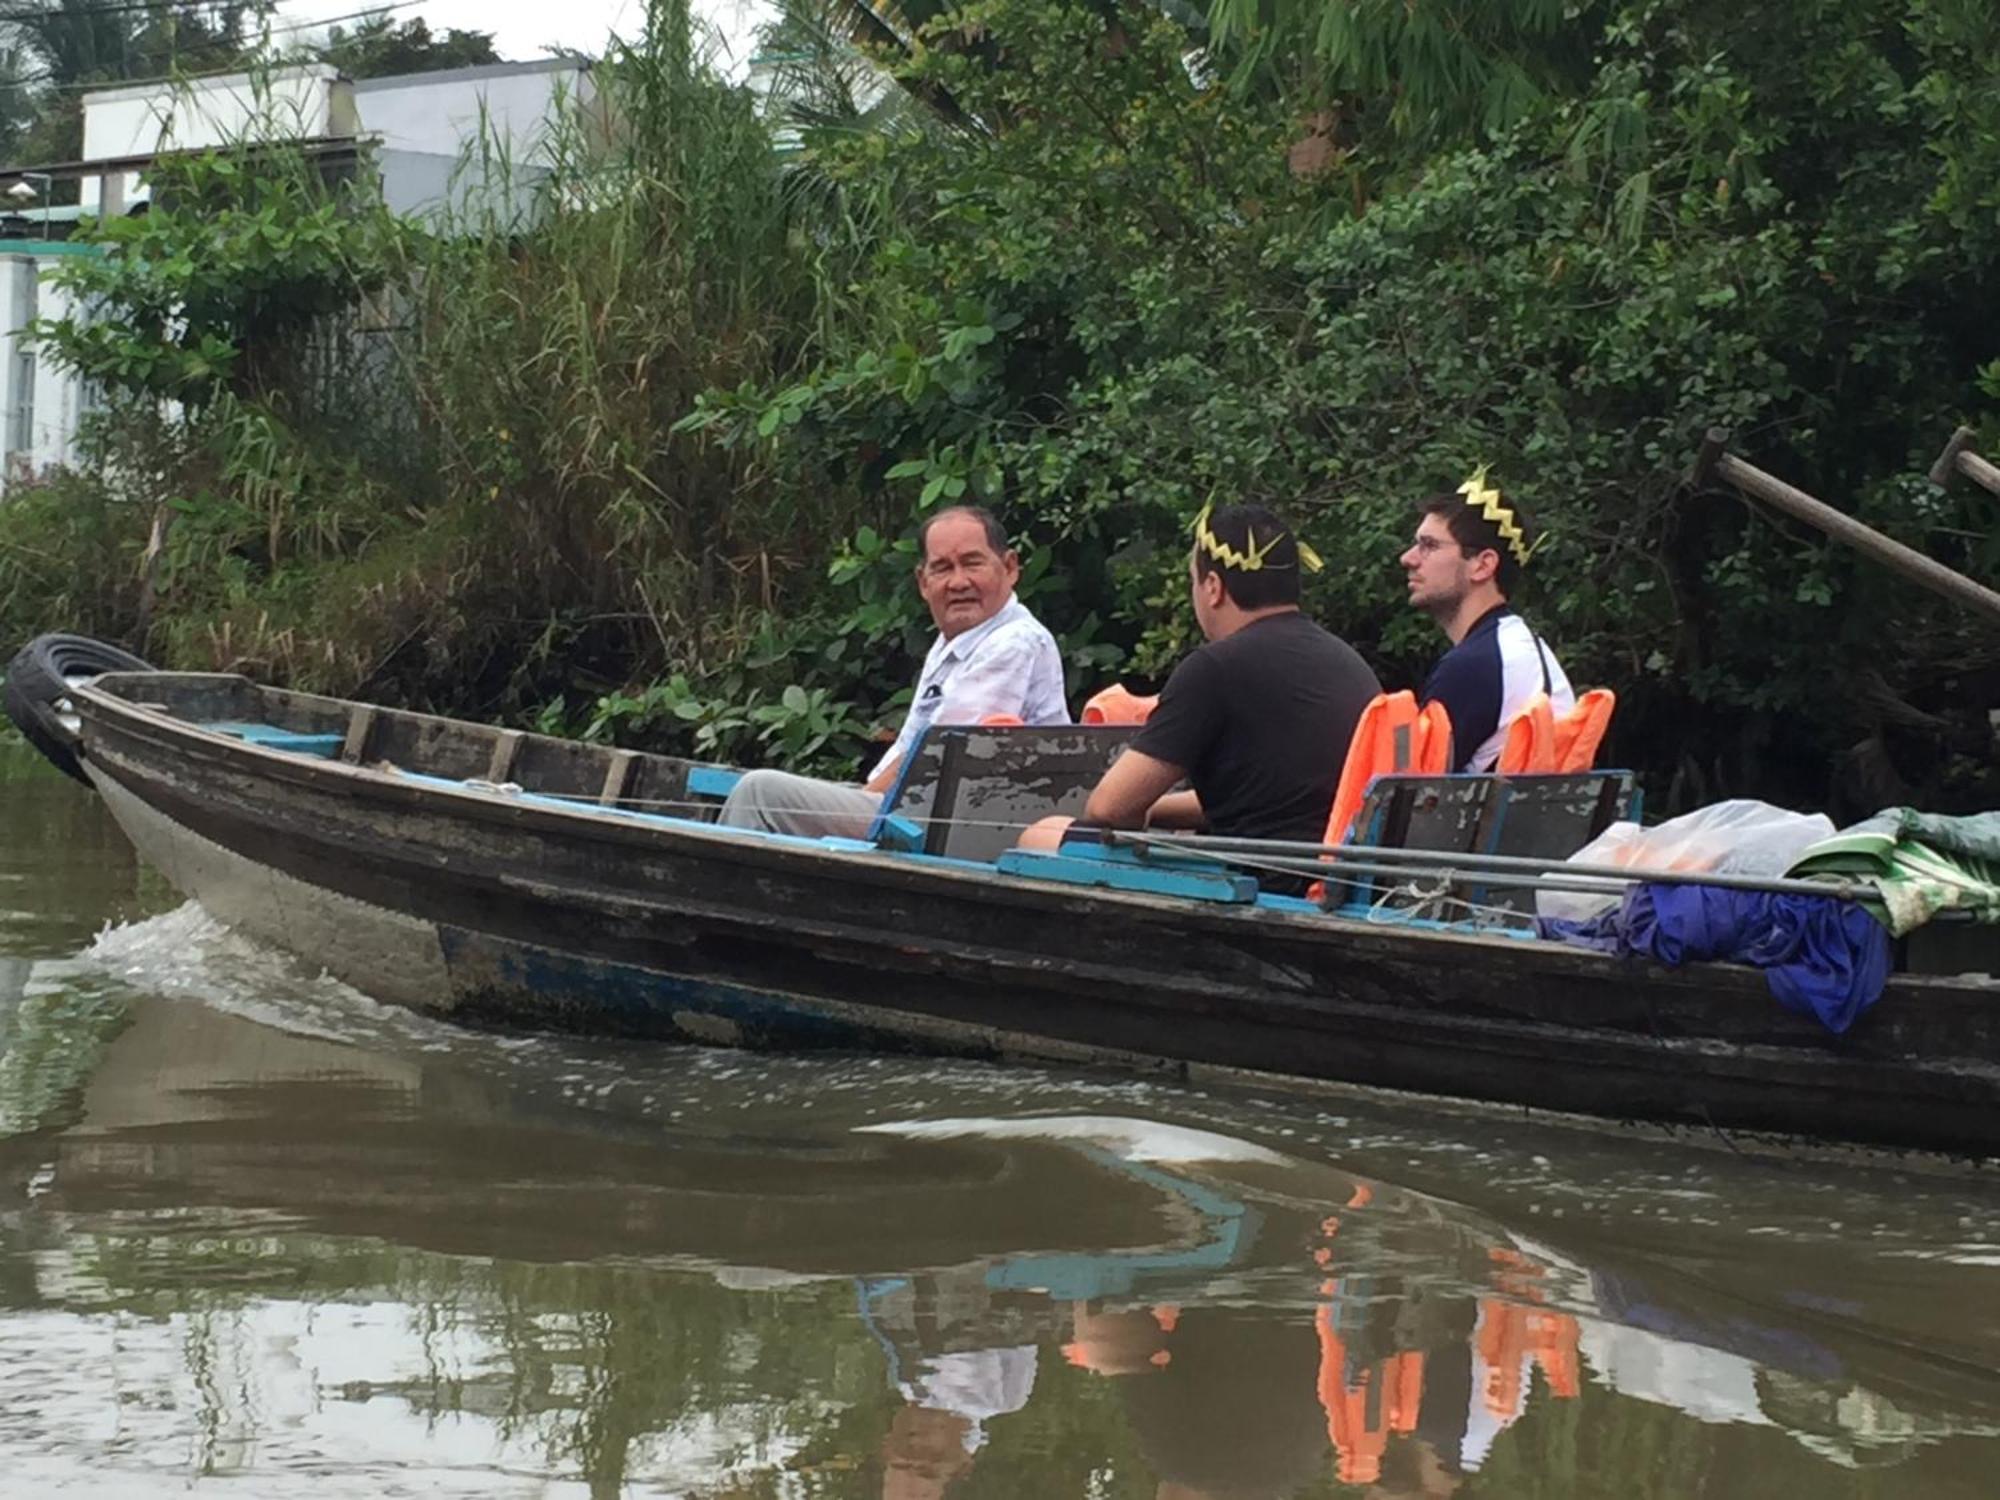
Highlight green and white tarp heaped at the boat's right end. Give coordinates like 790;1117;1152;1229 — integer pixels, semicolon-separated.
1786;808;2000;938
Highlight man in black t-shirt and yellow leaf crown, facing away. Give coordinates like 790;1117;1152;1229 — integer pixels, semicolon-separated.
1084;506;1382;842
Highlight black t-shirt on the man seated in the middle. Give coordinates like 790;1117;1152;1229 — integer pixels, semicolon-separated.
1132;610;1382;842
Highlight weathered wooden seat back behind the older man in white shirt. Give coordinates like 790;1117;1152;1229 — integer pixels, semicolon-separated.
868;724;1138;864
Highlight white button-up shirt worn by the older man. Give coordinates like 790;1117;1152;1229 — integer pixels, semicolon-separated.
868;594;1070;780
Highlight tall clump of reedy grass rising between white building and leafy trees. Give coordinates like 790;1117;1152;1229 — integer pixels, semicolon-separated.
398;0;868;692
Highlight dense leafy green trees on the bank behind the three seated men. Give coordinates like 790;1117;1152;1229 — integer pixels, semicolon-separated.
694;0;2000;806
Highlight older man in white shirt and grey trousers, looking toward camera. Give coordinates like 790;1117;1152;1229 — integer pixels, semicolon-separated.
720;506;1070;838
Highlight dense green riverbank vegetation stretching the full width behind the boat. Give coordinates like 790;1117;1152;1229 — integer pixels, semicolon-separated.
0;0;2000;812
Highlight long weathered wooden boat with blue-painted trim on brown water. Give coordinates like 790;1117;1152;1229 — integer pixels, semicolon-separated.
15;656;2000;1156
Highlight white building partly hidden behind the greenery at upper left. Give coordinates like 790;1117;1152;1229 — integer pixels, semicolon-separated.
0;58;596;482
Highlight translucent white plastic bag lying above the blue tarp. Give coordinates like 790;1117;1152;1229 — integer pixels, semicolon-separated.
1534;798;1834;922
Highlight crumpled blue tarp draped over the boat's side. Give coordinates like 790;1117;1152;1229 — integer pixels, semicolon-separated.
1542;886;1890;1032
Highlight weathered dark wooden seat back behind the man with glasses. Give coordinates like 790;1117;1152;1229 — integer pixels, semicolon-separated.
1346;770;1638;918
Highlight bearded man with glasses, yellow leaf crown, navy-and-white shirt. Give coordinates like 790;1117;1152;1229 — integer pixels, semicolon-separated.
1402;468;1576;772
